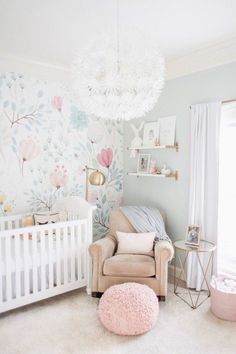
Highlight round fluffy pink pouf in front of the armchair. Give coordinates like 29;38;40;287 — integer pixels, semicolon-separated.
98;283;159;336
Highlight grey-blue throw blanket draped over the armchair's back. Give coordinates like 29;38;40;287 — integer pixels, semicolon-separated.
120;206;171;242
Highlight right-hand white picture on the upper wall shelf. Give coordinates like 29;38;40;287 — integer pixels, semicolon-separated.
159;116;176;146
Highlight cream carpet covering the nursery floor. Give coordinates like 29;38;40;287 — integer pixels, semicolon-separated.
0;286;236;354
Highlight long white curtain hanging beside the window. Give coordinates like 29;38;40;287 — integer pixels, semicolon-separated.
187;102;221;290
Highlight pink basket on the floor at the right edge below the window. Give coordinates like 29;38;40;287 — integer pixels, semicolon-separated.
210;277;236;321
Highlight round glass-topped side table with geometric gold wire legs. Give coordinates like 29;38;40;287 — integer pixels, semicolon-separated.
174;240;216;309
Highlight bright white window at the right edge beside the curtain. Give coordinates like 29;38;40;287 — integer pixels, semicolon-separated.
218;103;236;275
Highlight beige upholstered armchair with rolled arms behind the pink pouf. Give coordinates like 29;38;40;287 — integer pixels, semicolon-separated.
89;209;174;301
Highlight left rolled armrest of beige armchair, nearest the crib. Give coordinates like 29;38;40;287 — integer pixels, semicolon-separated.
89;237;116;292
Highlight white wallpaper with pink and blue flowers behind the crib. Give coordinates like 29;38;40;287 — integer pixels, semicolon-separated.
0;73;123;238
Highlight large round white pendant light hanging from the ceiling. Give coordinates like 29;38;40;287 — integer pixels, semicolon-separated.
73;2;165;121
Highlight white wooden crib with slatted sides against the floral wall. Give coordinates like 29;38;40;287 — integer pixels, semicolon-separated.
0;197;95;313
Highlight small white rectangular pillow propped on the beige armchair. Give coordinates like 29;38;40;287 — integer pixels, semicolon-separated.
116;231;155;256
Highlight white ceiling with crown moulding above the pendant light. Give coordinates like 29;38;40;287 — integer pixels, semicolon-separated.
0;0;236;68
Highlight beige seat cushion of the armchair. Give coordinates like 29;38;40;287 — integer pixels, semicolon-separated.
103;254;156;278
